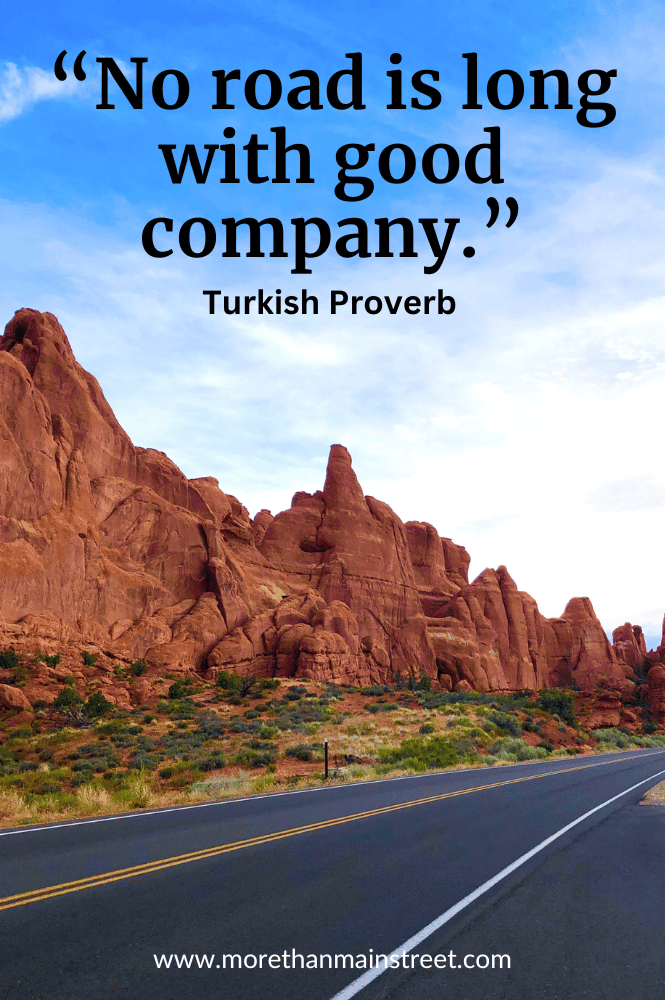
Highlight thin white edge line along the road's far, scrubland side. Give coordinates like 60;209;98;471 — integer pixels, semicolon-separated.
0;750;665;836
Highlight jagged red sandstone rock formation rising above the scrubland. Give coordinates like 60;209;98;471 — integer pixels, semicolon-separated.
0;309;648;704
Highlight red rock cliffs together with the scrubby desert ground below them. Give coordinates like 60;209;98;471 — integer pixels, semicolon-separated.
0;309;665;825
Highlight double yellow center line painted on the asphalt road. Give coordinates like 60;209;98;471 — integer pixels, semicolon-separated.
0;751;662;910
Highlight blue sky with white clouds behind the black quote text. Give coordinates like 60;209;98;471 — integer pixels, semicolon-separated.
0;0;665;642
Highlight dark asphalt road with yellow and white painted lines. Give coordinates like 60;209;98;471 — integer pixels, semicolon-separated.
0;751;665;1000
